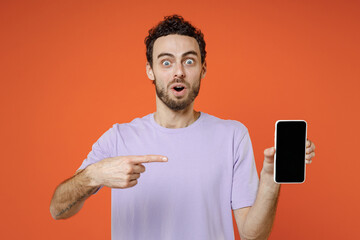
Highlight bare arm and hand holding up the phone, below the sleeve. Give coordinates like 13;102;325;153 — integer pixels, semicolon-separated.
234;140;315;240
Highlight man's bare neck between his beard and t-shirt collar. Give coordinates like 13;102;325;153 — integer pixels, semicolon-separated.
154;97;200;128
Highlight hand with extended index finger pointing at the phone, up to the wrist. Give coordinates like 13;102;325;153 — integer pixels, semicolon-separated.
88;155;167;188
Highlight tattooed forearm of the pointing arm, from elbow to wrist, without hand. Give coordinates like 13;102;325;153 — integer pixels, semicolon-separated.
50;169;98;219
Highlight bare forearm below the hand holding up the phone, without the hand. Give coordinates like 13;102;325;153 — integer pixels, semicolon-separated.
241;173;280;240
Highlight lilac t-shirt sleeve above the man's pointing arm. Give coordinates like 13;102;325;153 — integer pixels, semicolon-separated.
78;124;117;170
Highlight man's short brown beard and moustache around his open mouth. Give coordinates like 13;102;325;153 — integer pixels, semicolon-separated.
154;76;201;111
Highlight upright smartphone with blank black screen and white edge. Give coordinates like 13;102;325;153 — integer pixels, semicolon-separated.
274;120;307;183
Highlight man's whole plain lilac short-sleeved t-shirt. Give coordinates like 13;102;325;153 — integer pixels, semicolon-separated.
80;113;259;240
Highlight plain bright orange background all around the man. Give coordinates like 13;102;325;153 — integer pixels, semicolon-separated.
0;0;360;240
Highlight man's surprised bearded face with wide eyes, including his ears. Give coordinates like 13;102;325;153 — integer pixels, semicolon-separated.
146;35;206;111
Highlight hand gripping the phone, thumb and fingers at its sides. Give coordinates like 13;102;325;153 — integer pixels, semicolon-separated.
261;139;315;175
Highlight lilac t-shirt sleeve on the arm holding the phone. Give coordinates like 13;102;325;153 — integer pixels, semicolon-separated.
231;128;259;209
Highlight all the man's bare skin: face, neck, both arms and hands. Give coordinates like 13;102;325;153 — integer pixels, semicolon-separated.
50;35;315;239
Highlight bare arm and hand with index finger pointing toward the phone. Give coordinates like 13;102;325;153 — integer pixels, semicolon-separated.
50;155;167;220
